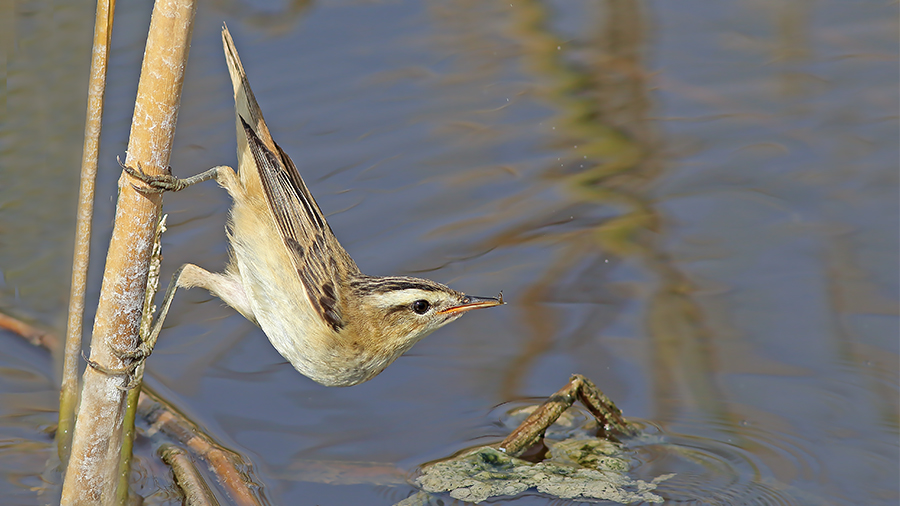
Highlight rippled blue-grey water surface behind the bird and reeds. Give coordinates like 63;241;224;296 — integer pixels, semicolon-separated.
0;0;900;505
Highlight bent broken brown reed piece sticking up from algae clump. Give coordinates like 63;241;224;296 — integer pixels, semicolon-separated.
498;374;638;457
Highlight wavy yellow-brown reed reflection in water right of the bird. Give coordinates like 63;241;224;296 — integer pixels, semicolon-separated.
432;0;719;418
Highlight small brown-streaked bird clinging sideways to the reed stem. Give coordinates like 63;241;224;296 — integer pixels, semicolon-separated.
124;26;504;386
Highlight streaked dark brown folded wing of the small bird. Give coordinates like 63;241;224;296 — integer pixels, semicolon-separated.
240;117;359;331
